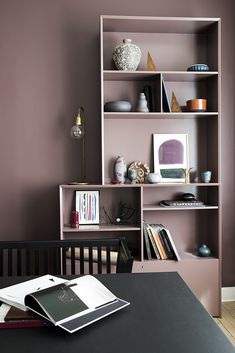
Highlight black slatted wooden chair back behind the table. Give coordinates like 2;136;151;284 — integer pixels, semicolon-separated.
0;238;133;276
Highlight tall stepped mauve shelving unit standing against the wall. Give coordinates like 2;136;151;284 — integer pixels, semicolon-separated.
60;15;222;316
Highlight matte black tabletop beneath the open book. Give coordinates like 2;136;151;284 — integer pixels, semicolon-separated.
0;273;235;353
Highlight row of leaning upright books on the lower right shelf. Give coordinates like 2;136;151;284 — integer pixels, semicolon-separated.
143;223;180;261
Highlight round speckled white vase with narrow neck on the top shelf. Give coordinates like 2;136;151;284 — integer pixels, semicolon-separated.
113;39;141;71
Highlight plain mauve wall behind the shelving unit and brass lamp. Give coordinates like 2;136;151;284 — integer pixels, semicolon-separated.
0;0;235;286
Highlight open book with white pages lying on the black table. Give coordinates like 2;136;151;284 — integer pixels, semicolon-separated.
0;275;130;333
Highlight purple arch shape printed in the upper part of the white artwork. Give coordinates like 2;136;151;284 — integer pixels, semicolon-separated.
158;139;184;164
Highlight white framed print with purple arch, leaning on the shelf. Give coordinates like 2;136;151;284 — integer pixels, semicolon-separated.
153;134;188;183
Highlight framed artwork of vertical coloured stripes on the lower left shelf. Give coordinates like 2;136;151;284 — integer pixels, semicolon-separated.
75;191;99;224
